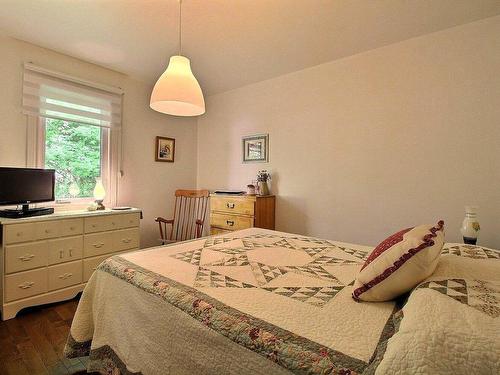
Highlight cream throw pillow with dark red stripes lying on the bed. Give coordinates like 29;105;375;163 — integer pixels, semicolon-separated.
352;221;444;301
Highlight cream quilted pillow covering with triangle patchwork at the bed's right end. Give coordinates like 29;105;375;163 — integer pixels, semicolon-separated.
372;244;500;375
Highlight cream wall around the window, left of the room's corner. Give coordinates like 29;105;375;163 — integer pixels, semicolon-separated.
0;35;197;247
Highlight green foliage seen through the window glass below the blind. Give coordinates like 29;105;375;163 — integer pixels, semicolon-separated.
45;119;101;199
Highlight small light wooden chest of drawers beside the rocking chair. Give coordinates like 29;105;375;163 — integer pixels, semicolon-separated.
210;194;275;235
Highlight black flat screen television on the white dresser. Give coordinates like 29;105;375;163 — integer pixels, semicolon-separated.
0;167;55;218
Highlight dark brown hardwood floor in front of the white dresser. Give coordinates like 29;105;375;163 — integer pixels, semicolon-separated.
0;297;87;375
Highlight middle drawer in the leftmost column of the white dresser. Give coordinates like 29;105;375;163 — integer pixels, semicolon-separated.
5;241;47;273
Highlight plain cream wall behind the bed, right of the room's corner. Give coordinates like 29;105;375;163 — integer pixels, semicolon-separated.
197;17;500;248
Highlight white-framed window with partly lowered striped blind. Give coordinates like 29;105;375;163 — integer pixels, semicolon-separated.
23;64;122;205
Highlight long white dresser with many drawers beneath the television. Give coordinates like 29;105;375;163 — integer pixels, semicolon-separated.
0;209;141;320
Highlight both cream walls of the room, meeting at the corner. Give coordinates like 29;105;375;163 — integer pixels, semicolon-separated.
0;17;500;248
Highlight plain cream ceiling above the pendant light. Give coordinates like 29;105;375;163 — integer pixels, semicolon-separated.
0;0;500;95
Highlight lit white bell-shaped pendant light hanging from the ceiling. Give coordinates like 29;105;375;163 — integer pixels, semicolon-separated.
149;0;205;116
